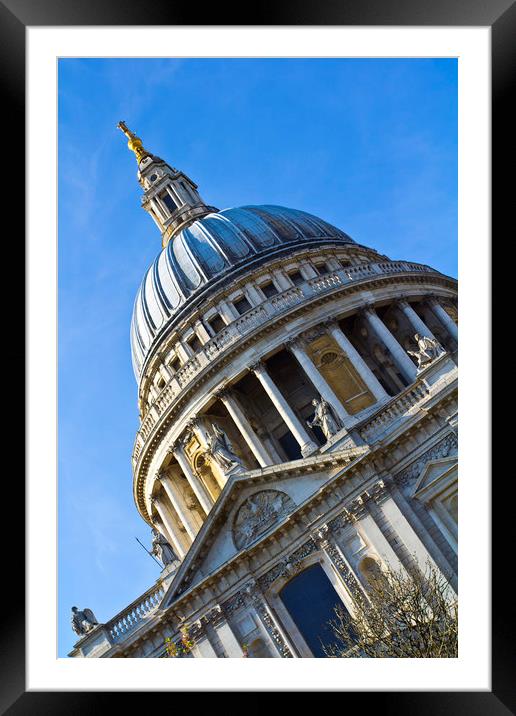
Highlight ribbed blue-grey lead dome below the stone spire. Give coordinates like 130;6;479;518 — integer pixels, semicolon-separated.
131;206;354;380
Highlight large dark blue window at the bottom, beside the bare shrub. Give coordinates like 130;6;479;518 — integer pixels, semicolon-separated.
280;564;347;657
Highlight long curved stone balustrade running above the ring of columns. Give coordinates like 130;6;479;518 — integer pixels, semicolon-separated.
133;261;437;464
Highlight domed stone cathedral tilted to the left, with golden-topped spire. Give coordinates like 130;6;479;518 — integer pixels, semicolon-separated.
70;122;458;658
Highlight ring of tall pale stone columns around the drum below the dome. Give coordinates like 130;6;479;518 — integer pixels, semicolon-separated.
149;297;457;559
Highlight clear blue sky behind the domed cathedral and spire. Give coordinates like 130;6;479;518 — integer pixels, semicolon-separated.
58;59;457;656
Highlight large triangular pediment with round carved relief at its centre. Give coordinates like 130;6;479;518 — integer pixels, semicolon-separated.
162;446;369;607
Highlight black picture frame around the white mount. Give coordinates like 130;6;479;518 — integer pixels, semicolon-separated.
6;0;510;716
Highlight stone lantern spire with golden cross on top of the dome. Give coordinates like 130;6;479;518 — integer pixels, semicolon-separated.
117;121;218;247
